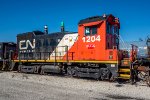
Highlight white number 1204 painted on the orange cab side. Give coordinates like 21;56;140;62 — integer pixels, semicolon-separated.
82;35;101;42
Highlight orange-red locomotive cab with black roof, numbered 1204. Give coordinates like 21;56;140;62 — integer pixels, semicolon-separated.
72;15;120;62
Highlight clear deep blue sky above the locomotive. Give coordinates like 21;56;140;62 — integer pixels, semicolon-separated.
0;0;150;42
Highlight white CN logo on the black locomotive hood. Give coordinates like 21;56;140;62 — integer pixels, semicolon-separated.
19;39;35;50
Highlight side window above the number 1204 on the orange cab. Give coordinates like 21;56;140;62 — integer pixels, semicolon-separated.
85;26;97;35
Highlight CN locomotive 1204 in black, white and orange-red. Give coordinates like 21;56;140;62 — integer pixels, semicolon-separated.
2;14;150;82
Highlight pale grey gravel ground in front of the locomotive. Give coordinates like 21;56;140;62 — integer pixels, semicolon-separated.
0;72;150;100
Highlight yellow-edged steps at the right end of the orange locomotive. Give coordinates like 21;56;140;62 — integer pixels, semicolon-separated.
118;58;131;80
